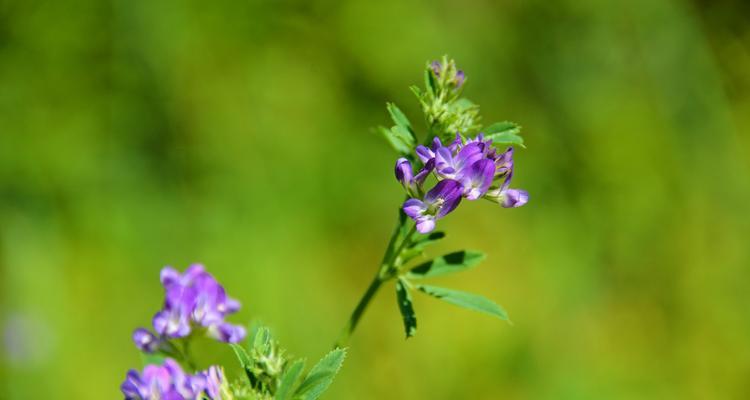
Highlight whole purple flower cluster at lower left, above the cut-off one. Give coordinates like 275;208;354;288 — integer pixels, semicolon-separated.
133;264;246;353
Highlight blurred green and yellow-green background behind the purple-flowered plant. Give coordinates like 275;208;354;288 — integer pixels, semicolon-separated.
0;0;750;399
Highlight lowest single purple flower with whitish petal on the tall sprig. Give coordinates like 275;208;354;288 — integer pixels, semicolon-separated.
403;179;463;233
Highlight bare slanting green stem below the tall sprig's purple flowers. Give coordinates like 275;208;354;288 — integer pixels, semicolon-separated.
334;214;416;347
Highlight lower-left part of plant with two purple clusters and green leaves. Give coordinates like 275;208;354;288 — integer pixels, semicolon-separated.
120;264;346;400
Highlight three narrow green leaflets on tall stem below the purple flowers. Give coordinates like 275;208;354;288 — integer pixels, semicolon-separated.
396;250;508;338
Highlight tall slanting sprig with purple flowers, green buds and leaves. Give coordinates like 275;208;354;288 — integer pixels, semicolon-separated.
337;57;529;345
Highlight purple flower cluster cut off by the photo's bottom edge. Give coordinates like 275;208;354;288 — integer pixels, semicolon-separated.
120;358;224;400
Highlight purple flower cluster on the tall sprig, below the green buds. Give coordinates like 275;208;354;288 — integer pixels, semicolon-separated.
396;133;529;233
